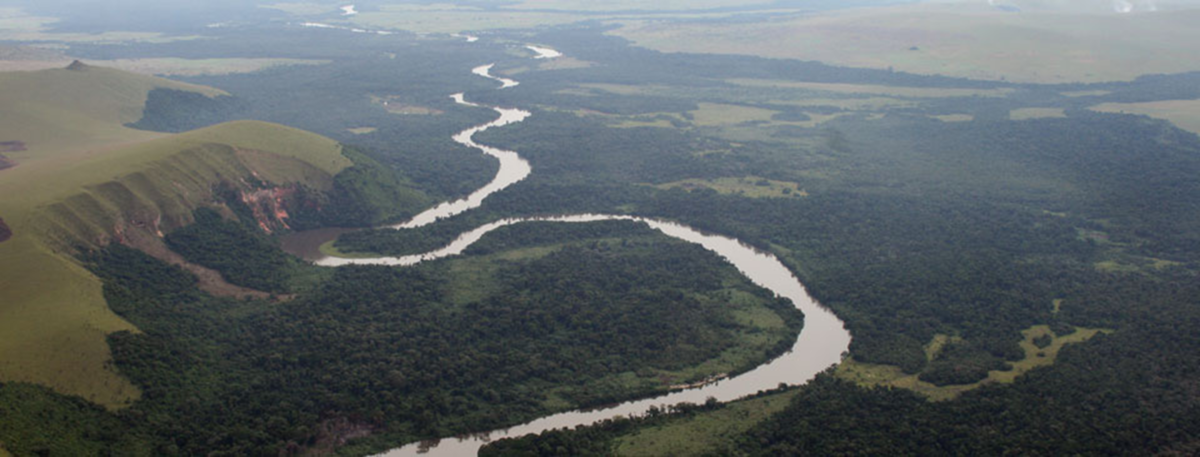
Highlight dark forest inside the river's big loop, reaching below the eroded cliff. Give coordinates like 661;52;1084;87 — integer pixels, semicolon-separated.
0;219;802;455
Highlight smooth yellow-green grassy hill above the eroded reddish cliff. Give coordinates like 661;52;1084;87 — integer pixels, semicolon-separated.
0;63;350;408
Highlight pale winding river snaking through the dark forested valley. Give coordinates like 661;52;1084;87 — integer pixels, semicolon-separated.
286;48;851;457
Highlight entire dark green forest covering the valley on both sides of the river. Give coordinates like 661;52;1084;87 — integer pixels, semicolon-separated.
0;13;1200;456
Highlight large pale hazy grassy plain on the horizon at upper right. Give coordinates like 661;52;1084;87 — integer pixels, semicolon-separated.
612;1;1200;83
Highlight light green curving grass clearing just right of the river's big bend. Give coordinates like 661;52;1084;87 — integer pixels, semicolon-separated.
836;325;1109;401
